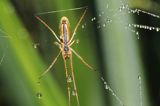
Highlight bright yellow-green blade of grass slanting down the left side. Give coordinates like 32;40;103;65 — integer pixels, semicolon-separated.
0;0;66;106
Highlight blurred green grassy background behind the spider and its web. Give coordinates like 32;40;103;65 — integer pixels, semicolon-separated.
0;0;160;106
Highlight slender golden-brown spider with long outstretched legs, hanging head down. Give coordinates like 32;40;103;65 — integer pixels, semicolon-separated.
35;7;95;106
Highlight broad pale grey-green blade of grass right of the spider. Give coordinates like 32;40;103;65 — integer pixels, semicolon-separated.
97;0;150;106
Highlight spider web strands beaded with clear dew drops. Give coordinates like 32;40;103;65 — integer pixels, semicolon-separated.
0;2;160;106
